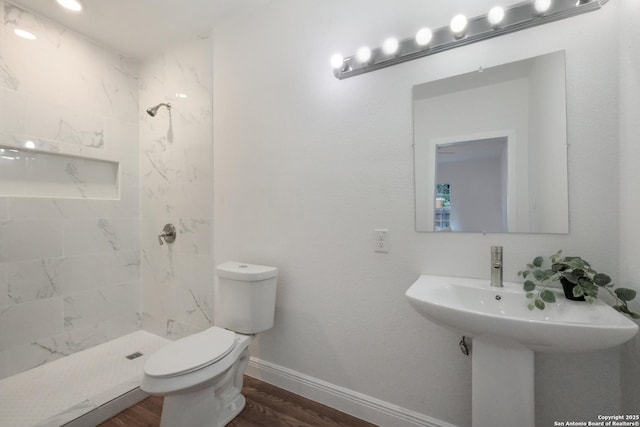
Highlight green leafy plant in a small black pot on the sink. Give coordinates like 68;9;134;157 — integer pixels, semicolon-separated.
518;251;640;319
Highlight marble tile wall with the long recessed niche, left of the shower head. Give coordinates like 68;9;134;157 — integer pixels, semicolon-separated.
0;0;140;378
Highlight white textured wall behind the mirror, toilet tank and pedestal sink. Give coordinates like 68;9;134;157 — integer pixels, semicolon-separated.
214;0;621;426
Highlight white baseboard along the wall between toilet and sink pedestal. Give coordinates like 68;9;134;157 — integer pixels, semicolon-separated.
246;357;456;427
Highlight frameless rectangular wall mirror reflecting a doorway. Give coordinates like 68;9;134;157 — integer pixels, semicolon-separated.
413;51;569;233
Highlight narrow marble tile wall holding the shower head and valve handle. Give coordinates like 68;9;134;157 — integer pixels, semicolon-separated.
139;38;214;339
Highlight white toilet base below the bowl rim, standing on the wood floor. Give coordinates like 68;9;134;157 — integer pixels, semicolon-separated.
160;349;249;427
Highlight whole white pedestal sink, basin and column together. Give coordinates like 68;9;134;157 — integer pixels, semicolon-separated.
406;275;638;427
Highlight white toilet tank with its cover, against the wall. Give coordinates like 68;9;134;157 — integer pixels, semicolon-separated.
216;262;278;334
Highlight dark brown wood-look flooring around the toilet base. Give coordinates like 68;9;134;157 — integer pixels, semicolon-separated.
99;376;375;427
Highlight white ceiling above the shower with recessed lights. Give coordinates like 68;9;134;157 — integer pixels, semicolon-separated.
8;0;271;58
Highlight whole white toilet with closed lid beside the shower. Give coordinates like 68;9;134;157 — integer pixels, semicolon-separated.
140;262;278;427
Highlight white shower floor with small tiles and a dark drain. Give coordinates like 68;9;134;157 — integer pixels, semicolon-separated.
0;331;170;427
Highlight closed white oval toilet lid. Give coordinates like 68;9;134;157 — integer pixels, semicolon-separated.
144;326;236;377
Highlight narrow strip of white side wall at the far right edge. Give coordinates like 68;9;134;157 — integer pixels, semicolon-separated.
620;0;640;414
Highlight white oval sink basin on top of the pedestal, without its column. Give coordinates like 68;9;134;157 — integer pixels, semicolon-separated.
406;275;638;352
